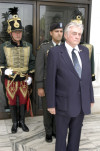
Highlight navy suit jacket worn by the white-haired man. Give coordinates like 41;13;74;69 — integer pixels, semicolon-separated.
46;44;94;117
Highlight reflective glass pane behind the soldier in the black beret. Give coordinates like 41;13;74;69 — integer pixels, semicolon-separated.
40;5;85;44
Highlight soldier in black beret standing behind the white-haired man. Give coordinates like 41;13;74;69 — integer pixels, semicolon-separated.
35;23;63;142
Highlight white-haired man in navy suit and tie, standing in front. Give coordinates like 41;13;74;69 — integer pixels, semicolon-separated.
46;21;94;151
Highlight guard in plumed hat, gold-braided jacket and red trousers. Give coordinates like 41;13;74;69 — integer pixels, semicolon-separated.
0;7;35;133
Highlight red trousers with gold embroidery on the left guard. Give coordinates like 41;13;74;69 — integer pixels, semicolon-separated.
5;79;28;105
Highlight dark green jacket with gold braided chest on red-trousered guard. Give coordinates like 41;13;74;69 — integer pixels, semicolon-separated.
0;41;35;81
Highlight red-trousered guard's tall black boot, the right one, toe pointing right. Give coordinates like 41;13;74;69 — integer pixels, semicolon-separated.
19;104;29;132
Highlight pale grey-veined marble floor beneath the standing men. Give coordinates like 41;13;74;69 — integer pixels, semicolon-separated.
0;114;100;151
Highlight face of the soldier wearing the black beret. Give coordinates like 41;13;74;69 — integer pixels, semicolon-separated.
50;28;63;43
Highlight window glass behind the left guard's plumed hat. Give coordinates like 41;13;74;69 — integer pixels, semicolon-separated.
0;3;33;44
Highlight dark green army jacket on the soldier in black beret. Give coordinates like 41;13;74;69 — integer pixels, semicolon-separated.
35;41;54;88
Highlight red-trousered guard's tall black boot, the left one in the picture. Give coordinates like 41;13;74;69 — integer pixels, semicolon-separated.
10;105;18;133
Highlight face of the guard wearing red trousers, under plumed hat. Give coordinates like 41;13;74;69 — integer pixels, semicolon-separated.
10;31;22;42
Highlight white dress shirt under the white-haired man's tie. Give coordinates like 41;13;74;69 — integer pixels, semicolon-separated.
65;42;82;68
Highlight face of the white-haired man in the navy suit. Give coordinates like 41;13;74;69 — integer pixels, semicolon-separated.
64;26;82;48
